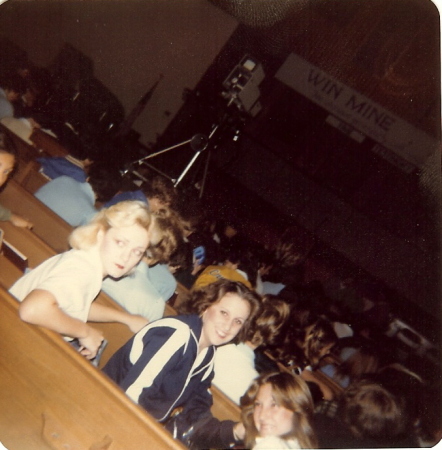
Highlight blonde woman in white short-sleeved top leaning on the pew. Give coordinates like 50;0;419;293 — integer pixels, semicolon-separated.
10;201;155;359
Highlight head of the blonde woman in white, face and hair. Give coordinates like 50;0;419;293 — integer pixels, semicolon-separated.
69;201;153;279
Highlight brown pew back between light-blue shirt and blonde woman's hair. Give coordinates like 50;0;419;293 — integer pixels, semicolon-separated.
0;180;73;253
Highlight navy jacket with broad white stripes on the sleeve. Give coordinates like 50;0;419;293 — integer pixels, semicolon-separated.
103;315;215;431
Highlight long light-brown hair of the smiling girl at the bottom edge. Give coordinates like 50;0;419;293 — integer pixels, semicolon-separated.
241;372;318;448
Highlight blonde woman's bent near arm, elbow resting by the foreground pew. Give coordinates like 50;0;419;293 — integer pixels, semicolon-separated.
18;289;103;359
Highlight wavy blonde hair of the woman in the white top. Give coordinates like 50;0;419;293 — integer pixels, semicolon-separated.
69;200;153;250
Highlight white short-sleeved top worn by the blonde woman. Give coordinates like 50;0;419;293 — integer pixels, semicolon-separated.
9;248;103;322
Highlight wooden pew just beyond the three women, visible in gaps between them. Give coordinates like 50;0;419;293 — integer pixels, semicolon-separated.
0;222;240;421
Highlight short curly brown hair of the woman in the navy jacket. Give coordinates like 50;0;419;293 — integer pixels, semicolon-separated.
180;279;261;344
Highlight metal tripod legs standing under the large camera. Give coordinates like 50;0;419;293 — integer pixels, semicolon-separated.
122;125;219;198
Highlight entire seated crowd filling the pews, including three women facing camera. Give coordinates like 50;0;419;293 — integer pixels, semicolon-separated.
0;65;441;449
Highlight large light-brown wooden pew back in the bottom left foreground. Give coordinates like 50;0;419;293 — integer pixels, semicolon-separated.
0;289;184;450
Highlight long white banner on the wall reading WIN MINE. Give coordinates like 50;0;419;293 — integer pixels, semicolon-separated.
276;53;439;167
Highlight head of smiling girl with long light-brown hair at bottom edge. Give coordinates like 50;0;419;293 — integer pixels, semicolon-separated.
241;372;317;448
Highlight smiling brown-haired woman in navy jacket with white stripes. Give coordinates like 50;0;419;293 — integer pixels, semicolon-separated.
103;280;260;439
